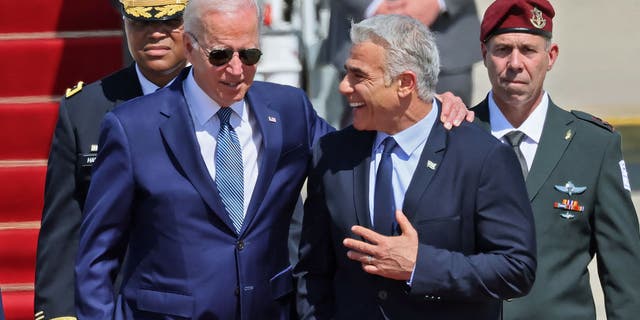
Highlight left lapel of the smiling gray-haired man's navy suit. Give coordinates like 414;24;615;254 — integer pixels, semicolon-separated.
351;129;376;228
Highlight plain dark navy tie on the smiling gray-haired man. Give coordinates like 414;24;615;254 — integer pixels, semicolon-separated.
373;137;396;235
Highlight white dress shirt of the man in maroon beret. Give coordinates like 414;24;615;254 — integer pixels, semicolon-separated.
489;92;549;170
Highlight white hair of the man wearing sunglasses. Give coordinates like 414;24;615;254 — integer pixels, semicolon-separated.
183;0;262;42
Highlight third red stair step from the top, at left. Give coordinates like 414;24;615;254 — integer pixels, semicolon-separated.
0;102;58;159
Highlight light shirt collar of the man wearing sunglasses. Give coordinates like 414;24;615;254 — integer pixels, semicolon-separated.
183;69;249;125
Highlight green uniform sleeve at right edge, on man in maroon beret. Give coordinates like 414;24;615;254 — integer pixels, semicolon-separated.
593;133;640;320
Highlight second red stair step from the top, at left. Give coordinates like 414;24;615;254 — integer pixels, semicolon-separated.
0;36;123;97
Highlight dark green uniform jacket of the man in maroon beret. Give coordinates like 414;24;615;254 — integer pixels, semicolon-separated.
472;100;640;320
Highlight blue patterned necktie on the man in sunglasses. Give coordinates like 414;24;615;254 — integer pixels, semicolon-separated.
216;107;244;233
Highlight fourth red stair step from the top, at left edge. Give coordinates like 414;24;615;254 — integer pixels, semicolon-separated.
0;165;47;222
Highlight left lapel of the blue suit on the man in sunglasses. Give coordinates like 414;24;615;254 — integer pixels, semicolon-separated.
160;73;235;233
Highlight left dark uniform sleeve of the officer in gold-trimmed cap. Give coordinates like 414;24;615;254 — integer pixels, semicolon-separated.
34;100;82;319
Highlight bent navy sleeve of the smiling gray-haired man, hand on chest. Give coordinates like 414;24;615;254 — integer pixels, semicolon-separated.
411;144;536;301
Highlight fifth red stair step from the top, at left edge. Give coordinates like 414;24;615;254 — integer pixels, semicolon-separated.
0;229;40;284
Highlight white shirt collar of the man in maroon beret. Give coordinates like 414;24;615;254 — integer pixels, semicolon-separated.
489;92;549;143
